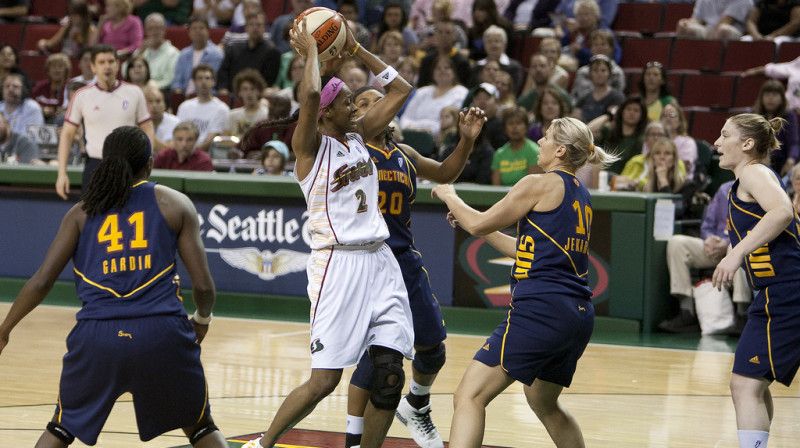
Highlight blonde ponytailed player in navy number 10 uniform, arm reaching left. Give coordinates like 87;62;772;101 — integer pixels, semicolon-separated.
431;118;617;448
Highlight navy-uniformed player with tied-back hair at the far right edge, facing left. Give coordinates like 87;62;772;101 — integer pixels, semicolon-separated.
711;114;800;448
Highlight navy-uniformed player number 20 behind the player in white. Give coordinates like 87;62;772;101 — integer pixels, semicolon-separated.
346;86;486;448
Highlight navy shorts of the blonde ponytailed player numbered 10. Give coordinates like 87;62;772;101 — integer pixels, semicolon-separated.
474;294;594;387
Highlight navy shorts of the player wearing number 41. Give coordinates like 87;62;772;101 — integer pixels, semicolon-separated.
56;315;209;445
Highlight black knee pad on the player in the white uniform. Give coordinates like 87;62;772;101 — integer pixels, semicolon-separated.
369;347;406;410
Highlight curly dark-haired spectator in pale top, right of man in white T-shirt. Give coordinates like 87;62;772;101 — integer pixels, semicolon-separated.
222;68;268;139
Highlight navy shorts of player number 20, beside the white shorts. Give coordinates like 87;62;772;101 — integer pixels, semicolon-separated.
394;246;447;347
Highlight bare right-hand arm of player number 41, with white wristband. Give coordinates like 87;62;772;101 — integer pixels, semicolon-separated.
156;185;216;342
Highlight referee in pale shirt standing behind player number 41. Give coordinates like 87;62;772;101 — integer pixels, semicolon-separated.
56;44;154;199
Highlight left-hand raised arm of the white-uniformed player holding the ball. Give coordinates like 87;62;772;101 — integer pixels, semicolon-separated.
289;19;322;179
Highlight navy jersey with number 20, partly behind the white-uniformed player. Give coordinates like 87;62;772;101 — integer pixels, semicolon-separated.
367;142;417;250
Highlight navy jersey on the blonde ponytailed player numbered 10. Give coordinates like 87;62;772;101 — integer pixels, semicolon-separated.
511;171;592;300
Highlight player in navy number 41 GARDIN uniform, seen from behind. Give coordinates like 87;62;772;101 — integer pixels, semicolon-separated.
0;126;228;448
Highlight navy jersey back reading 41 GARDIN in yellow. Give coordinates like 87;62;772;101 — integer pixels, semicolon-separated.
73;181;185;319
